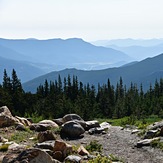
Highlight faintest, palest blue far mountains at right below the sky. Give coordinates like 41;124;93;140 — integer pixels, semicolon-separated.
93;39;163;61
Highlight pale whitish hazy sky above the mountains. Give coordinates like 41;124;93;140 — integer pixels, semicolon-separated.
0;0;163;41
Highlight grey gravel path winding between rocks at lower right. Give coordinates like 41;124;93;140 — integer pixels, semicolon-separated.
67;126;163;163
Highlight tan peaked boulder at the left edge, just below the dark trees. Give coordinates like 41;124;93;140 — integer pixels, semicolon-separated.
0;106;19;127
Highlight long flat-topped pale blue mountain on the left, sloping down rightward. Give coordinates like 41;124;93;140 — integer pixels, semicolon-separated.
0;38;132;70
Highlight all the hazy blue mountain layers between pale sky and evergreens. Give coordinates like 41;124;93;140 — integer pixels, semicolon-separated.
0;38;163;92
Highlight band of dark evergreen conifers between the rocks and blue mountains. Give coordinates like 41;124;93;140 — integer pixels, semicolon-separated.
0;69;163;124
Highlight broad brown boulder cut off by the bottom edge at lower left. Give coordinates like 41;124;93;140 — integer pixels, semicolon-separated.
2;148;54;163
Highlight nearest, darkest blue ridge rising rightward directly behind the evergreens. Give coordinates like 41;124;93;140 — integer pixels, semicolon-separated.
23;54;163;92
